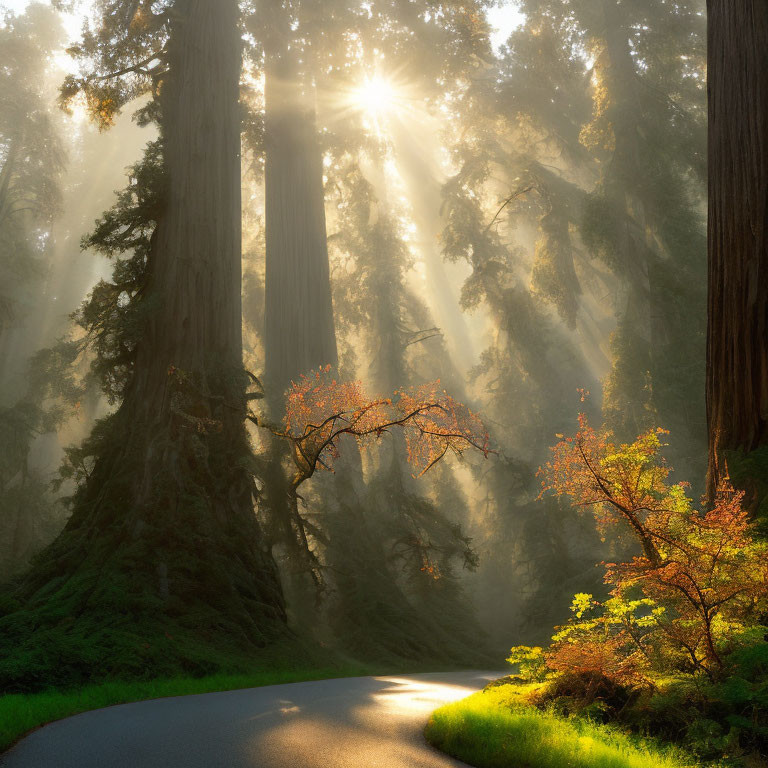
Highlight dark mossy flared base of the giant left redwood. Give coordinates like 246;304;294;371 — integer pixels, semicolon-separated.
0;413;288;692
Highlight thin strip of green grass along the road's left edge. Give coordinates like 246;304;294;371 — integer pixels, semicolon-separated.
0;665;380;753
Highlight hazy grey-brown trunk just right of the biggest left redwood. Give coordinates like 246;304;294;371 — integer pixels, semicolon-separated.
265;9;337;411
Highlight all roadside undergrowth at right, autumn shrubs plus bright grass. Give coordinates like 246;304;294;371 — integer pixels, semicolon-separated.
428;414;768;767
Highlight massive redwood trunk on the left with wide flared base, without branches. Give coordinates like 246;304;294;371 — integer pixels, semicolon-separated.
0;0;284;681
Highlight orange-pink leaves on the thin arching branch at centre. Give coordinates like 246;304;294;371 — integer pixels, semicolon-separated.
282;366;490;485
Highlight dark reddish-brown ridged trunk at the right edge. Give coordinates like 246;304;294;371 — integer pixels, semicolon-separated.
707;0;768;496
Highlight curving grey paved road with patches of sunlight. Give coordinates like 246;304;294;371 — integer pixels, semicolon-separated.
0;672;503;768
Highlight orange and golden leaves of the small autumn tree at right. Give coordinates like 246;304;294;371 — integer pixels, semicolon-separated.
539;414;768;676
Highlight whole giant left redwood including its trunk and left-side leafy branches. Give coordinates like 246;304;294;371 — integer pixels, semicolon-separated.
0;0;284;686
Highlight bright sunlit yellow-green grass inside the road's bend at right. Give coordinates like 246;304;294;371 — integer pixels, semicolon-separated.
426;685;698;768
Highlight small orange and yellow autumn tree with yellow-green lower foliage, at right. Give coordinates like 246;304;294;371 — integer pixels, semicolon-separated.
540;414;768;683
